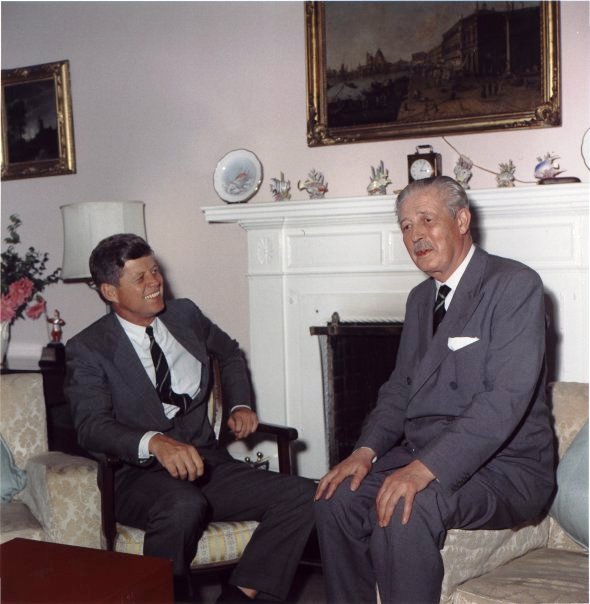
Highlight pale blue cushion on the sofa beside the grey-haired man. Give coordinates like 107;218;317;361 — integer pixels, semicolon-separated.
549;422;588;549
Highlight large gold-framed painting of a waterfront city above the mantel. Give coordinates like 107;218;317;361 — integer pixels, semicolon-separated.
305;0;561;147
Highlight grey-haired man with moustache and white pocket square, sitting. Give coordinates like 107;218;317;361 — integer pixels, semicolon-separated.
316;177;554;604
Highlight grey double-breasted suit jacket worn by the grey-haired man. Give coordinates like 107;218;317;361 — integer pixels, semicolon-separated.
357;248;554;505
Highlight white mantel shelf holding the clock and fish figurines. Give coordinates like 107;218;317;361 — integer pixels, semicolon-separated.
202;183;590;230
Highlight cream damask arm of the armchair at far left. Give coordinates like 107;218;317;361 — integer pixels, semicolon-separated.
21;451;101;548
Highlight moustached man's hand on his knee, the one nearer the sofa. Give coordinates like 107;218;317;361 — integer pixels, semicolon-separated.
375;459;436;527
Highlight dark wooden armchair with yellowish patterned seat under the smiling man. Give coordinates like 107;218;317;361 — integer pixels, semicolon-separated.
98;361;298;572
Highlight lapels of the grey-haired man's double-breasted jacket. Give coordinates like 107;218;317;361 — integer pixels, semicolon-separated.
410;247;487;398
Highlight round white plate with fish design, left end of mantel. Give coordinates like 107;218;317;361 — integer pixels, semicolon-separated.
213;149;262;203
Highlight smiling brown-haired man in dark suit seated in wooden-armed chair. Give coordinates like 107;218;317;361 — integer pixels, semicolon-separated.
65;234;315;602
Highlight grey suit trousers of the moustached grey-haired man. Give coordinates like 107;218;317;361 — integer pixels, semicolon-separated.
315;462;552;604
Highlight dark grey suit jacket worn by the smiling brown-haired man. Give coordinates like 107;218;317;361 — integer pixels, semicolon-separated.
65;300;251;465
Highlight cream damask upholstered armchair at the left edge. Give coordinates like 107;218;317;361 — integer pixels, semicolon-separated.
0;373;100;547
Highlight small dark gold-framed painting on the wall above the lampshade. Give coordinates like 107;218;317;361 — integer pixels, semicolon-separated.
2;61;76;180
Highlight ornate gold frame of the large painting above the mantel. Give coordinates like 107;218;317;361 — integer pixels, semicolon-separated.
305;0;561;147
